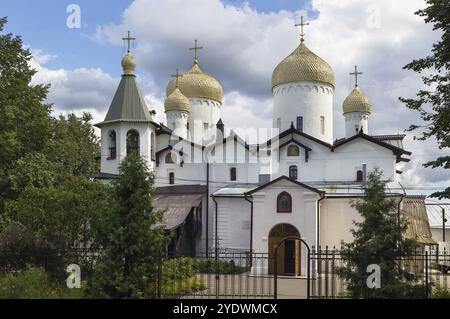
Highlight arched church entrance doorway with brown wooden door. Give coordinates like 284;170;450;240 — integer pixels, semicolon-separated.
268;224;301;276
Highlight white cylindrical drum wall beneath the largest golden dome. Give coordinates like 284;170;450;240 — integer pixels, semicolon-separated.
272;81;334;143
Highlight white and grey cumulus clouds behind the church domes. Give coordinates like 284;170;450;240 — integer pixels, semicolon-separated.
29;0;448;189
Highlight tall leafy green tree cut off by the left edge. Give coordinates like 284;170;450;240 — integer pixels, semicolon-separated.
0;18;51;212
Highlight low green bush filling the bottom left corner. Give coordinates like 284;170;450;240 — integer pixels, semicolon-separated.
0;267;83;299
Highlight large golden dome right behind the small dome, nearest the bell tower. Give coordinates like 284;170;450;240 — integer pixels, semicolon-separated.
166;62;223;103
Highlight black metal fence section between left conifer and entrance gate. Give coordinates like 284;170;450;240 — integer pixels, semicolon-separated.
157;253;273;299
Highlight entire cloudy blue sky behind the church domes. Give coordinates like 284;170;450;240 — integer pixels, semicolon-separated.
0;0;449;190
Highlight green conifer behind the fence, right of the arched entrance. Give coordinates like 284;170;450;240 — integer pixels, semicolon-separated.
338;170;423;298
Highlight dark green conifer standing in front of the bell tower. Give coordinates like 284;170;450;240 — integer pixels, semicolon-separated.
91;155;168;298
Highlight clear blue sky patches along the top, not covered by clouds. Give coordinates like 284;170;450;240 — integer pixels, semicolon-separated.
0;0;308;76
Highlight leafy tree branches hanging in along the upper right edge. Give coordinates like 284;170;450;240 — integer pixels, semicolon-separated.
400;0;450;199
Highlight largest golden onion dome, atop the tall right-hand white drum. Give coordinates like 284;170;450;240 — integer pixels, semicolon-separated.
272;41;335;88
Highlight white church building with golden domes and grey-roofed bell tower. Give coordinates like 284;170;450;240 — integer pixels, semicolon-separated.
96;29;434;274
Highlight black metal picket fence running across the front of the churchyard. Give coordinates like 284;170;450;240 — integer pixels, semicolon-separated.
37;247;450;299
